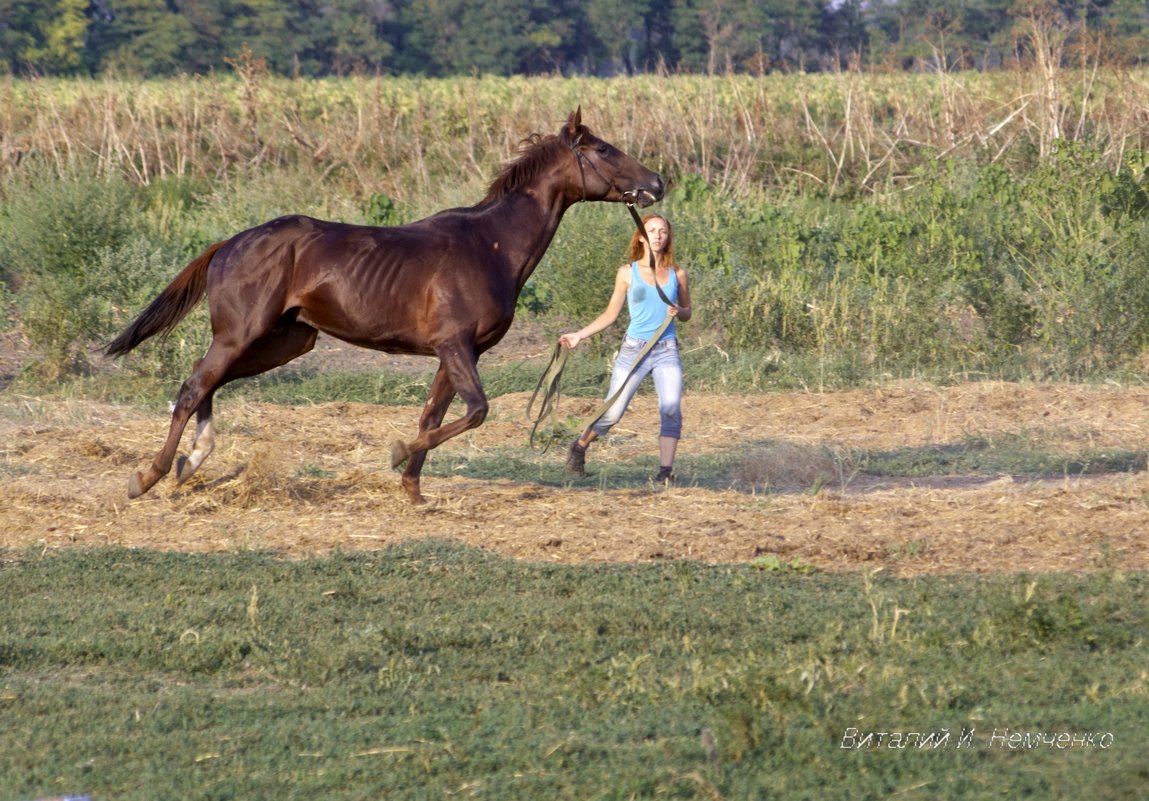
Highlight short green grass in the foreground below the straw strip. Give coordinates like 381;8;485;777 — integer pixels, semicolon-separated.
0;544;1149;801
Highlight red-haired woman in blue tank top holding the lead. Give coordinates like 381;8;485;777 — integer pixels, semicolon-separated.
558;215;691;483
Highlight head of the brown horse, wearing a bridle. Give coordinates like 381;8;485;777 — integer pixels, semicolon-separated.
558;106;666;208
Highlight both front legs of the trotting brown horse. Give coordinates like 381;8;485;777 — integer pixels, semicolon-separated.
391;340;488;503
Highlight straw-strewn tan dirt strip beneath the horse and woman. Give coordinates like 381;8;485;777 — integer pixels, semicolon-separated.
0;328;1149;576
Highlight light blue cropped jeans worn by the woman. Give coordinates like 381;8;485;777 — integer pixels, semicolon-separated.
591;337;683;439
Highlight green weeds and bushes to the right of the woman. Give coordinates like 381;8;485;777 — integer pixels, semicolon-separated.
652;144;1149;379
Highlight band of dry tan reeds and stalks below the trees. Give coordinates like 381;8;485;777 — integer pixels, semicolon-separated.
0;66;1149;200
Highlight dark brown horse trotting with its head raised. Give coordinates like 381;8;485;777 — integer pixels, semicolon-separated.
107;109;664;503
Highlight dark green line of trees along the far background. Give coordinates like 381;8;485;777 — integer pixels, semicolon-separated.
0;0;1149;77
